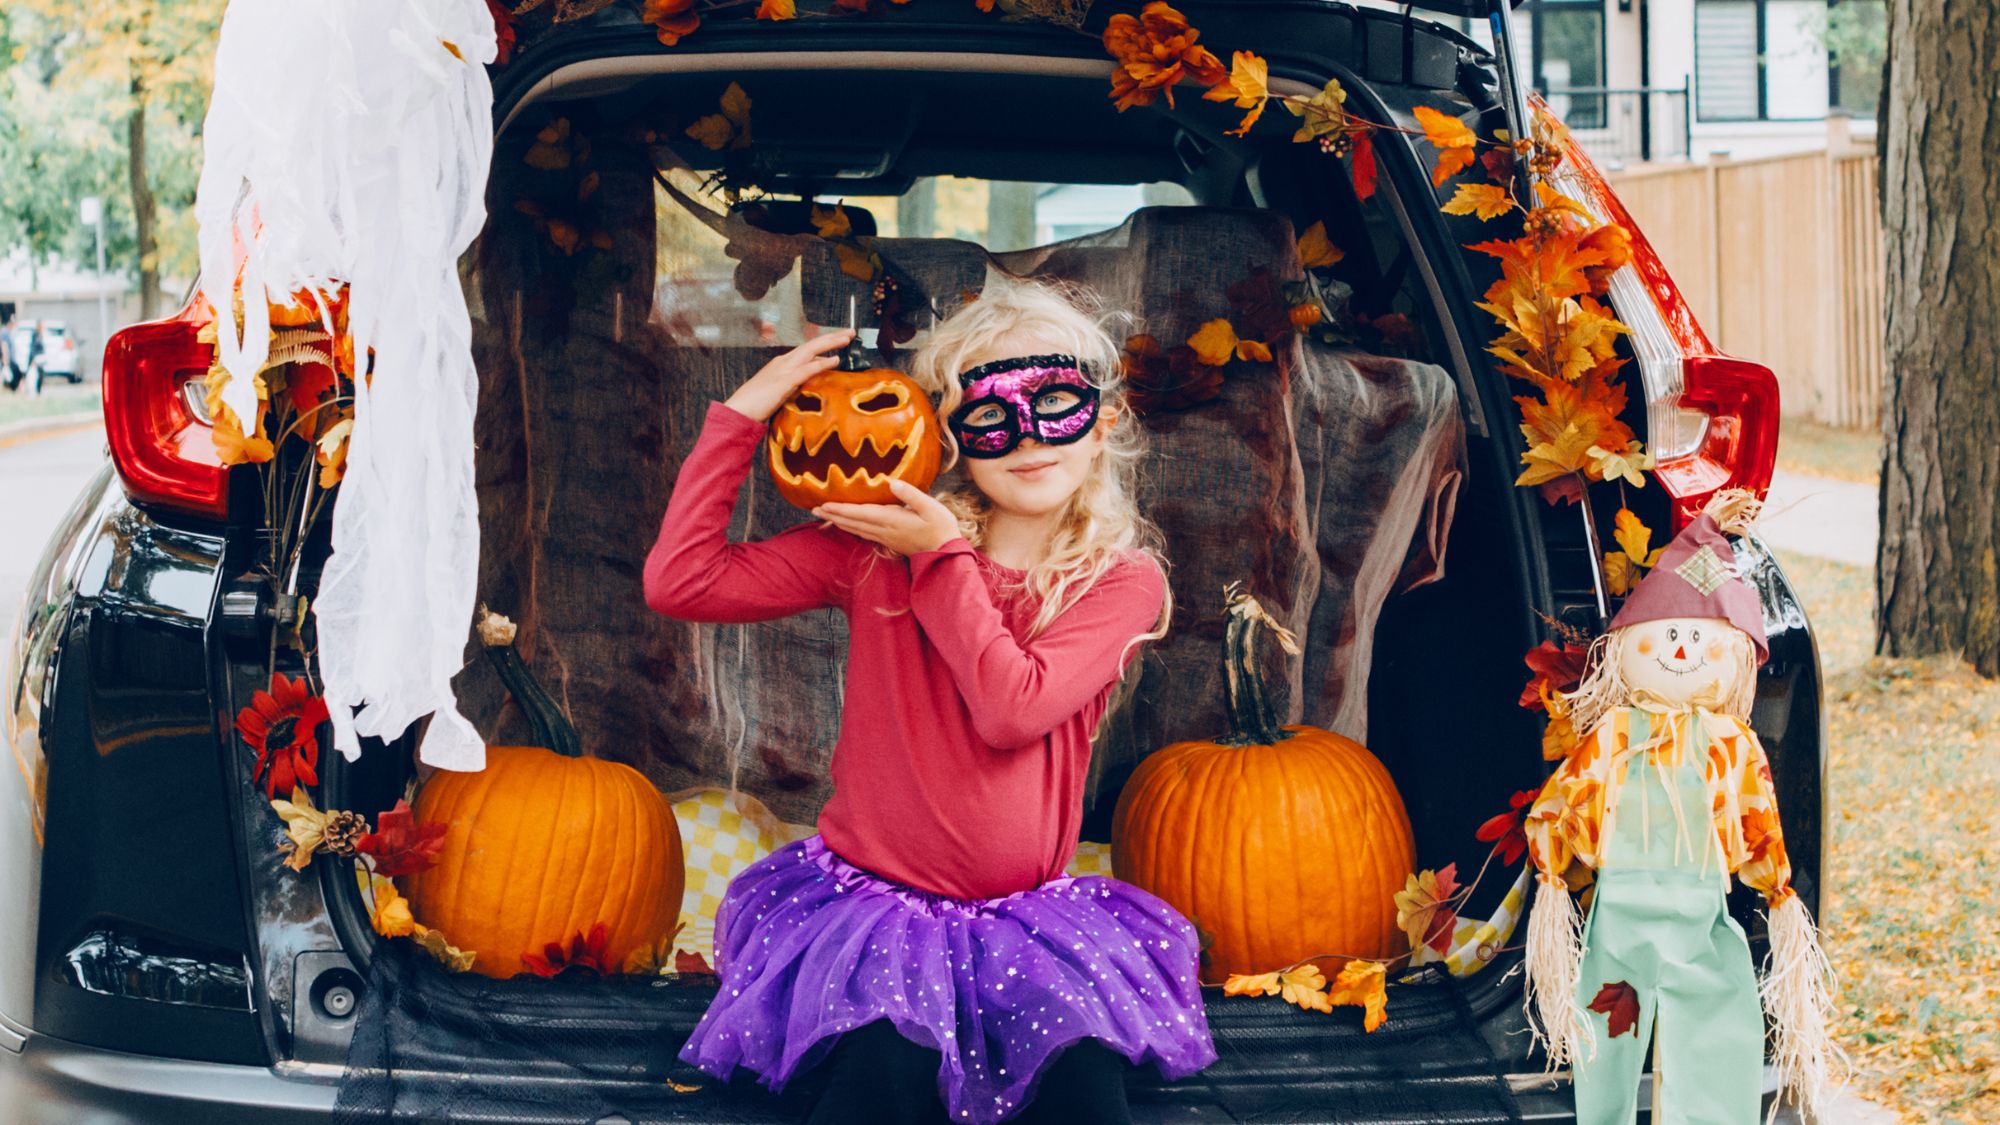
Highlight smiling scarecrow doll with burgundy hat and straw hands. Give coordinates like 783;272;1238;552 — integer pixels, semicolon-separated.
1526;490;1834;1125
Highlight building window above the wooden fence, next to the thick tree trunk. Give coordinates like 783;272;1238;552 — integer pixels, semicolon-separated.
1694;0;1886;122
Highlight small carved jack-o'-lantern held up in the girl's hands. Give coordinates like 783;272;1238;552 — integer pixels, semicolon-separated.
766;368;944;508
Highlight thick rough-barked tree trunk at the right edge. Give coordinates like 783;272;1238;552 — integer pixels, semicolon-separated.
1876;0;2000;664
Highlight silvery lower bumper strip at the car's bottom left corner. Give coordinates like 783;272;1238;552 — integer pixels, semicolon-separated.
0;1033;340;1125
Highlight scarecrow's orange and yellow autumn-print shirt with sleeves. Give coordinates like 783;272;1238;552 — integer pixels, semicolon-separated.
1526;705;1792;907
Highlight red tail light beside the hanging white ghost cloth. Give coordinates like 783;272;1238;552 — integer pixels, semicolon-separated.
104;306;228;520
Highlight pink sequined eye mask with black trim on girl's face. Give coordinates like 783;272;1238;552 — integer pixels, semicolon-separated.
950;356;1098;458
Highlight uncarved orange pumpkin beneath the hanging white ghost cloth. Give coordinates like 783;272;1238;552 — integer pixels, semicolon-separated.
408;615;686;977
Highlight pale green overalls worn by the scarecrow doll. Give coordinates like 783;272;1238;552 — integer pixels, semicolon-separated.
1574;709;1764;1125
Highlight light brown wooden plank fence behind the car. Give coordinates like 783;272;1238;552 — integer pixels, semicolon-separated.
1610;118;1884;428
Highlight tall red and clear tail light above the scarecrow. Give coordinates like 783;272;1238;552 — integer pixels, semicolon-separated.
1538;106;1778;530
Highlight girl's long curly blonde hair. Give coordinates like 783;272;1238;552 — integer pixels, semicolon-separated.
910;274;1174;643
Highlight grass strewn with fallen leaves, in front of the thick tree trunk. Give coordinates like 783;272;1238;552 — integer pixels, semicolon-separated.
1780;552;2000;1125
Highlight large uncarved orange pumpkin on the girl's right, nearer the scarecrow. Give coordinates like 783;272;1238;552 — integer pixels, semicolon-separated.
1112;589;1416;983
